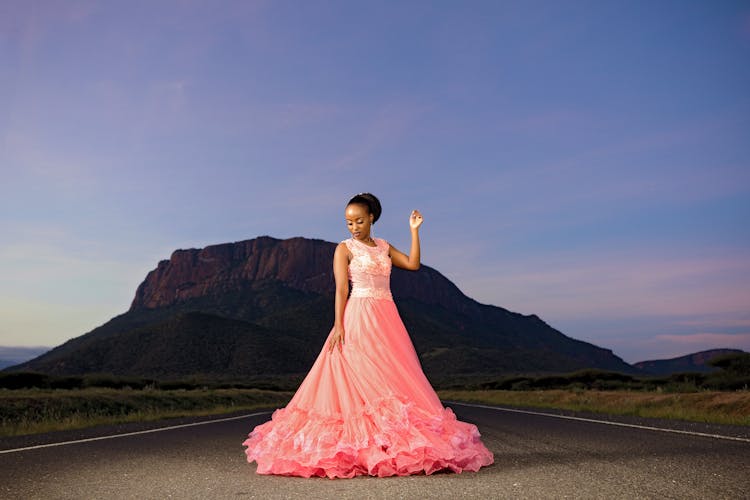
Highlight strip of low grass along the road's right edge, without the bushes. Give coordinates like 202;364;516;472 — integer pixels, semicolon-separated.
438;389;750;425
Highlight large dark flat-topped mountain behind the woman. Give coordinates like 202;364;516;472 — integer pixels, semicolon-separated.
7;236;634;379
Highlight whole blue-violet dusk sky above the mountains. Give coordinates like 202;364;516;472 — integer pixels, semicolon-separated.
0;0;750;362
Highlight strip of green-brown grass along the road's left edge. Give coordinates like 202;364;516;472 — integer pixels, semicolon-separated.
0;387;292;436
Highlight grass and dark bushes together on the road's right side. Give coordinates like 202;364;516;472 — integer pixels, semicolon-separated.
438;353;750;425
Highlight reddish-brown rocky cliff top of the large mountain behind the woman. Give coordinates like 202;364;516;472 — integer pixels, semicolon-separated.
130;236;476;312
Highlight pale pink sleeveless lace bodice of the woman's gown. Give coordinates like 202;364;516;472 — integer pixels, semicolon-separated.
344;238;393;300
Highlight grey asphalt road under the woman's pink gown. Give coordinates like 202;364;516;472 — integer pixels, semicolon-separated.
0;402;750;499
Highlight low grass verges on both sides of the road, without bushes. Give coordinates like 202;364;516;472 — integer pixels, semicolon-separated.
0;387;750;436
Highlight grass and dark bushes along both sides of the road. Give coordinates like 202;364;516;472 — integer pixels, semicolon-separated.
0;353;750;436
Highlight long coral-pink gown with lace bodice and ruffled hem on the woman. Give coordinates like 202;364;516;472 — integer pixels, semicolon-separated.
242;238;494;478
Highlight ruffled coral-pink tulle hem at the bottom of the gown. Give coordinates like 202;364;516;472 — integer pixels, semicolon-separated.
242;396;494;479
